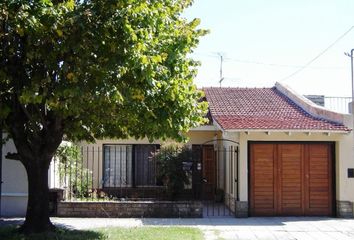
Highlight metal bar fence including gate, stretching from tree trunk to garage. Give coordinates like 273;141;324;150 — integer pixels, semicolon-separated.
50;144;237;216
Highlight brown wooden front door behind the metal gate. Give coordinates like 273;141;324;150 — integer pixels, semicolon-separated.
202;145;216;199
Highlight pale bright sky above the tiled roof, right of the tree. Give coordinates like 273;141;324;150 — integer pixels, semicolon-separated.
184;0;354;97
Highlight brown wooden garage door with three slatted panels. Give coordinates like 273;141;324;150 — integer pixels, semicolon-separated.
250;143;333;216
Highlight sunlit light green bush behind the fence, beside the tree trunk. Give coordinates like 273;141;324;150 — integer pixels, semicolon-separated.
55;145;93;199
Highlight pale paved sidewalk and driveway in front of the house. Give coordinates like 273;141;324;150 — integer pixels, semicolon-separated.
0;217;354;240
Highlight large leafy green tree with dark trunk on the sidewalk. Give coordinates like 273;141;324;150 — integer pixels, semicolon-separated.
0;0;206;233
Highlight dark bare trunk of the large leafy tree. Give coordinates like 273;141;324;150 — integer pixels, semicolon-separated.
19;158;55;234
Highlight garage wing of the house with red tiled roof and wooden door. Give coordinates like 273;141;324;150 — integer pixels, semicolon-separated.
205;83;354;216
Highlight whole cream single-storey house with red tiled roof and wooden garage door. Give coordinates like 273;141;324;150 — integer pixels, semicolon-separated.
3;83;354;217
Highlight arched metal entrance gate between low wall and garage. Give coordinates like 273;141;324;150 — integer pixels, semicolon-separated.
192;139;238;217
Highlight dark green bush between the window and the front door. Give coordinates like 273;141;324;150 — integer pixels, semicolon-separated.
155;145;192;199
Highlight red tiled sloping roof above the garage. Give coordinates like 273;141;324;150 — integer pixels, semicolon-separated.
203;87;349;131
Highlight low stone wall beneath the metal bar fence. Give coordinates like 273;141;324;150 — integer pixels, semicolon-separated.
57;201;203;218
